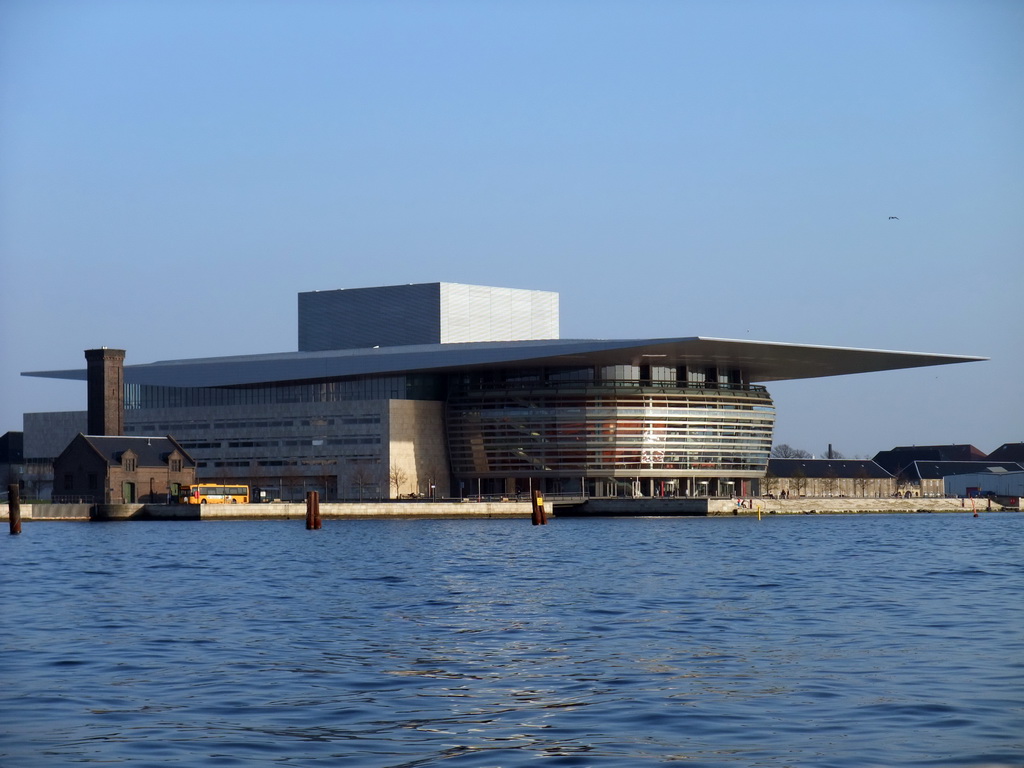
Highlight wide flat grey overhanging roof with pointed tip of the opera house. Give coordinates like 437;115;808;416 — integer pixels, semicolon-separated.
23;336;986;387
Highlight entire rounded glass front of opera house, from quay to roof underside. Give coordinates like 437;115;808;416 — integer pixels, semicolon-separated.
445;366;775;497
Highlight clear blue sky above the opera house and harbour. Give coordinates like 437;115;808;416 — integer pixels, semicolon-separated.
0;0;1024;456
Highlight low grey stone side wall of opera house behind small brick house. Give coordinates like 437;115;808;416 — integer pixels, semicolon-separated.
25;387;450;501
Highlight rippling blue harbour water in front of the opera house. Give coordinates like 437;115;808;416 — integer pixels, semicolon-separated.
0;513;1024;768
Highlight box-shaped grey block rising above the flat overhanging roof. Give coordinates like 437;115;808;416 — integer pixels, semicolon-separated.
298;283;558;352
